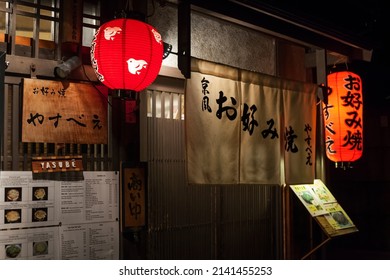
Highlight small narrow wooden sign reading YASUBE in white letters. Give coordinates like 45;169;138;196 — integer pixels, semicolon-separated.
31;156;83;173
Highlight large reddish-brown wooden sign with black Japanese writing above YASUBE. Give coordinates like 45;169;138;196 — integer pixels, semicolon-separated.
22;79;108;144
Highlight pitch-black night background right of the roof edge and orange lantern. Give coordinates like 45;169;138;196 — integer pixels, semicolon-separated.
260;0;390;259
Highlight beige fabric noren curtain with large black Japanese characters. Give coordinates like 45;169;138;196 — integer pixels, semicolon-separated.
185;58;317;184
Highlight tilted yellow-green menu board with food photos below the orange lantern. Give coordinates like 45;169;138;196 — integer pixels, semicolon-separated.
290;179;357;236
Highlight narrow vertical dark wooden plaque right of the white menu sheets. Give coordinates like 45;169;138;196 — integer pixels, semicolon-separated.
120;162;147;231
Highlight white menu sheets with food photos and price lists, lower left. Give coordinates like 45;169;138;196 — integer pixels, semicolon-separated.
0;171;119;259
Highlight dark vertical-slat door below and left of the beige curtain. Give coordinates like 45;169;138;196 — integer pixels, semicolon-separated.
145;90;282;259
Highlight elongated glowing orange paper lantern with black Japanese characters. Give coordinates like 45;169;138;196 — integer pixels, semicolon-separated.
323;71;363;163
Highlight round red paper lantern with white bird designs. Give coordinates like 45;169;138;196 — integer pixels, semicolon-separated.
91;18;164;91
